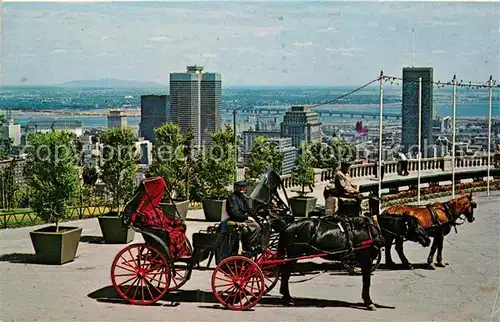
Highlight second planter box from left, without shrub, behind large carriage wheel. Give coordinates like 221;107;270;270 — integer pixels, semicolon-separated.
98;212;135;244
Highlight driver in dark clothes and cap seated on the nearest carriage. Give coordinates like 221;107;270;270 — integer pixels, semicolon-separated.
226;181;261;252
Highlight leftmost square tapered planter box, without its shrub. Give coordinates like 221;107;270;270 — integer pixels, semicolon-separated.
30;226;82;265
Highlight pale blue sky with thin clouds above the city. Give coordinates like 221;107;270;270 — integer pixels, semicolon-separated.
2;1;500;86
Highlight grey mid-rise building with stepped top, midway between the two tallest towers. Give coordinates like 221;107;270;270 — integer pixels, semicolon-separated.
281;106;321;149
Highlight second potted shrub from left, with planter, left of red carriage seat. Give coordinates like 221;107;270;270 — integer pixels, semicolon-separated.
98;128;137;244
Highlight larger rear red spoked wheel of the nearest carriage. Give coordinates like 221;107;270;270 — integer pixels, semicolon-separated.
111;244;170;305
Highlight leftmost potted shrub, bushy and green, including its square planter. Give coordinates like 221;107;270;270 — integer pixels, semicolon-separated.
24;131;82;265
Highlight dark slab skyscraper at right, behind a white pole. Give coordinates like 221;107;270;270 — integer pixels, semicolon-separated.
401;67;434;156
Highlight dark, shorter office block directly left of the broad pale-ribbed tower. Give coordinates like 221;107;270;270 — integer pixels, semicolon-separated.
139;95;169;142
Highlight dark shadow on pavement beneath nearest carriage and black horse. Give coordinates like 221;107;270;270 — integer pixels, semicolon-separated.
87;285;395;310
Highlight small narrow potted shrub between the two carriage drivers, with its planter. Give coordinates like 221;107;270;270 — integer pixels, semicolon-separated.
288;143;318;217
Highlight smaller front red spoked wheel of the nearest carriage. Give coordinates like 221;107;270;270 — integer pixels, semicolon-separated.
212;256;265;311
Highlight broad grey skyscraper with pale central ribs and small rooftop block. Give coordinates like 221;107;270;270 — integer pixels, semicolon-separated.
170;65;221;146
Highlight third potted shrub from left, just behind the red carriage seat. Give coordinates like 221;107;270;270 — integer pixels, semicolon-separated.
150;123;194;220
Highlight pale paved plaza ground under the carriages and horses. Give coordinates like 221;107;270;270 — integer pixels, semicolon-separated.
0;190;500;321
